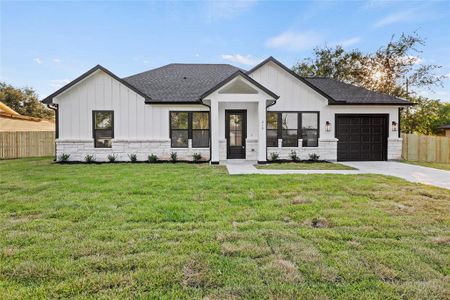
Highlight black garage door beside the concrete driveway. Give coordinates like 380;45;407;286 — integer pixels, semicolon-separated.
336;114;388;161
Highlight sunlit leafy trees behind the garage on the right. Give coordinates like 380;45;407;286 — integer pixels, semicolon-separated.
292;32;450;134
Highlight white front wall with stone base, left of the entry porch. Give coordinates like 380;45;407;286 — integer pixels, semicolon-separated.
53;70;209;161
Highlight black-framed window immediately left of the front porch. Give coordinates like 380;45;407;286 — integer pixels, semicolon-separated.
170;111;209;148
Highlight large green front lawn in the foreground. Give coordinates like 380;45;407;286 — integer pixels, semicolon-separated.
0;158;450;299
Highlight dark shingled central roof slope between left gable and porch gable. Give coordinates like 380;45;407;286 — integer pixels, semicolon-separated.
123;64;240;103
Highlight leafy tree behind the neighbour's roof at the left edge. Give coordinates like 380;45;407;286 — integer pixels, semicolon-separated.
0;82;54;119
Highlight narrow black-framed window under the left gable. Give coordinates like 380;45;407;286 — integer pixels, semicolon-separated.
92;110;114;148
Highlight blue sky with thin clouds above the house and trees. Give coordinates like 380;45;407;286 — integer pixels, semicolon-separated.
0;0;450;101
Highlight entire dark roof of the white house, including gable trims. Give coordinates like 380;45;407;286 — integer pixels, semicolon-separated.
42;57;412;105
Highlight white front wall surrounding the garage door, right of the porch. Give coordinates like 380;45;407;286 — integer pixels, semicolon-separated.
250;62;401;160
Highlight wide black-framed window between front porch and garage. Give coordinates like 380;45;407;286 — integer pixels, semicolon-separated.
266;111;319;147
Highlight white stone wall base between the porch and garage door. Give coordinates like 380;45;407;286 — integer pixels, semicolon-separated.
267;139;337;161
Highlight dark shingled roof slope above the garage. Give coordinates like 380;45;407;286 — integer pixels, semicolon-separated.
305;77;411;105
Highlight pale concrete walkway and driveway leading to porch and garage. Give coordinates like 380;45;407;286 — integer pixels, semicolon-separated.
223;160;450;189
